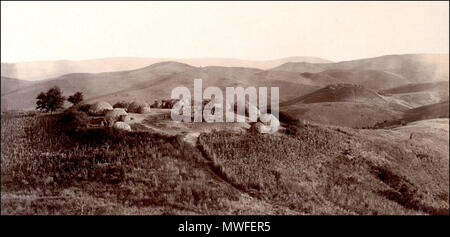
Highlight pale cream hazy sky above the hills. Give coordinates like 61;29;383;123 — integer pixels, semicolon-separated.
1;2;449;62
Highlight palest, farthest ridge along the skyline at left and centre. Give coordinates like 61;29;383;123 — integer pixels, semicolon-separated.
1;57;331;81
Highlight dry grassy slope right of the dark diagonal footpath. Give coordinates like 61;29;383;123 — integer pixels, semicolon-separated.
199;122;448;215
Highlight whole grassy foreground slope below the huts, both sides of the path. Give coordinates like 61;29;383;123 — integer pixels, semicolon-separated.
1;113;449;215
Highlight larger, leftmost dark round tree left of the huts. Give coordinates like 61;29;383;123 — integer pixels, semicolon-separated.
36;86;66;112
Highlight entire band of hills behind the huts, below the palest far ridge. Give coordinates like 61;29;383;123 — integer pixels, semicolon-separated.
1;55;448;124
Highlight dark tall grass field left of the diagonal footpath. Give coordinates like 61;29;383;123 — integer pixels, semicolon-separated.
1;115;237;214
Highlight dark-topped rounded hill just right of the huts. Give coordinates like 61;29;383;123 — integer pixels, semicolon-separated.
280;84;409;128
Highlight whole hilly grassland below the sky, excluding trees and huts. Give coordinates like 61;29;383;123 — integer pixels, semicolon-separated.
1;54;449;215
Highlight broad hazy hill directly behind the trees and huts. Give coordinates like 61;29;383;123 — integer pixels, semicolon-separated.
2;62;319;110
